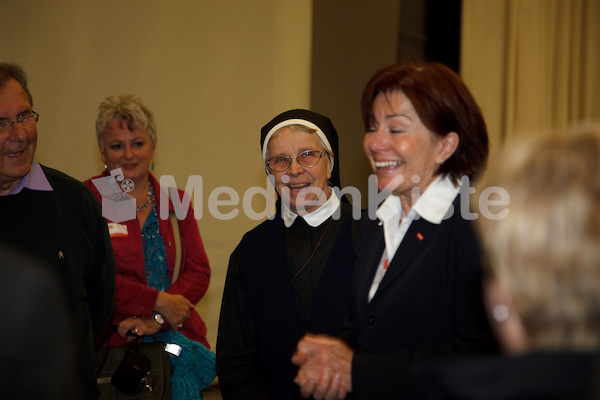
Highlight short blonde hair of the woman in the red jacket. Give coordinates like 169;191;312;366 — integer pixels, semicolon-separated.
96;94;156;151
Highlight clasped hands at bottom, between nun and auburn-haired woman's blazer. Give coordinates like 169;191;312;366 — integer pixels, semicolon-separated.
292;334;354;400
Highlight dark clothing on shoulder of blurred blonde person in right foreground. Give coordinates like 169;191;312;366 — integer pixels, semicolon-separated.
400;351;600;400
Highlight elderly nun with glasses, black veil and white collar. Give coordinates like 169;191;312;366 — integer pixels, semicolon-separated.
216;110;358;400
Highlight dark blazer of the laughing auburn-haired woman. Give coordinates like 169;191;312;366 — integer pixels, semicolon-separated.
342;196;497;399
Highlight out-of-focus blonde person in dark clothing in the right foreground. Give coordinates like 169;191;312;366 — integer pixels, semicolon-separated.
398;123;600;399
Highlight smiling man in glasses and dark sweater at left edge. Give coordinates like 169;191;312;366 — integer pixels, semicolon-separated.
0;63;115;399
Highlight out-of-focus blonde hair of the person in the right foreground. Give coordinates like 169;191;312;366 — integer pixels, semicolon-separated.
477;125;600;350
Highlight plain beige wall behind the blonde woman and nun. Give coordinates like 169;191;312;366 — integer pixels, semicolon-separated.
0;0;312;345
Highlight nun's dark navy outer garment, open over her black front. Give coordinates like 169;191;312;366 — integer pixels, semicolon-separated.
216;204;356;400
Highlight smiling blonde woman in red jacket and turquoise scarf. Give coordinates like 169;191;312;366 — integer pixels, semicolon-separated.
84;94;215;400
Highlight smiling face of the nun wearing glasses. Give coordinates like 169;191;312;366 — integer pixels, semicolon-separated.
267;128;331;215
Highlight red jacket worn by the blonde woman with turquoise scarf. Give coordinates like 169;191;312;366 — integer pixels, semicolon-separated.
84;172;210;348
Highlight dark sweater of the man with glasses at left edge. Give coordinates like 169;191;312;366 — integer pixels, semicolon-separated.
0;165;115;399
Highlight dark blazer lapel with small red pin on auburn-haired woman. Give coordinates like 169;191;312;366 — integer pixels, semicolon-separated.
375;218;439;297
